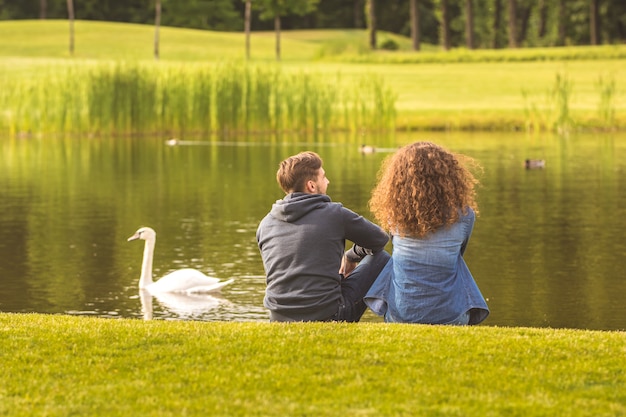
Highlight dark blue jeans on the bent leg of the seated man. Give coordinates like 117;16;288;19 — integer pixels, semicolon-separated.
330;250;391;322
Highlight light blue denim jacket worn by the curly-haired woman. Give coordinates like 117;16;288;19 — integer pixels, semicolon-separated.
365;209;489;324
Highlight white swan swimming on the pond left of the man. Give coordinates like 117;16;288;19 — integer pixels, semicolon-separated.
128;227;234;294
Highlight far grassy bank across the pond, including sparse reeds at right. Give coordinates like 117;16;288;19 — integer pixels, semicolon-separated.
0;21;626;131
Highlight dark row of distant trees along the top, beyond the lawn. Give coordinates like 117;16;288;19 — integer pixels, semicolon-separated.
0;0;626;49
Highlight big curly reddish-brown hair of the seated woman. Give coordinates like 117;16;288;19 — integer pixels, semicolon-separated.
369;142;478;237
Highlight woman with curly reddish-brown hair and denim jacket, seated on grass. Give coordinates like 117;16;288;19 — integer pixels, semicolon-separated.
366;142;489;325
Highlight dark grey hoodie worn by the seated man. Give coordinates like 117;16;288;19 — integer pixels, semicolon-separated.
256;193;389;321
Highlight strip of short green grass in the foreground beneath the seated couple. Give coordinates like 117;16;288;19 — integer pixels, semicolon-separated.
0;314;626;416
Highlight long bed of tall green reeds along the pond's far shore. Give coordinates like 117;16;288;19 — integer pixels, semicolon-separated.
0;63;395;136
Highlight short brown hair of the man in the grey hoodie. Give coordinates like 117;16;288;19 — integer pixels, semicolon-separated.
276;151;322;194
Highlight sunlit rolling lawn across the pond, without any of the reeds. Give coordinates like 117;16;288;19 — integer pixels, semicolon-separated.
0;20;626;128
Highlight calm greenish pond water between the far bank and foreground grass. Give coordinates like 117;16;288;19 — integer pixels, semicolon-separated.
0;133;626;330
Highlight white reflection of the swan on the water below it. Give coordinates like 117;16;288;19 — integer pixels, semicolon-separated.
139;290;230;320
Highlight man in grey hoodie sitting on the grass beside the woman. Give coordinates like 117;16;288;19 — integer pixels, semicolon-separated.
256;152;390;322
